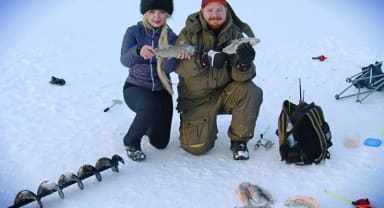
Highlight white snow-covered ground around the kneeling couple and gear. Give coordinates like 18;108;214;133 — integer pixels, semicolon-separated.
0;0;384;208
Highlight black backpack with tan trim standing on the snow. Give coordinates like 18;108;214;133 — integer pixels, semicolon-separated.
276;100;332;165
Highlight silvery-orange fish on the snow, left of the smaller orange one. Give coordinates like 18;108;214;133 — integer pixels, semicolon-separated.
236;182;273;208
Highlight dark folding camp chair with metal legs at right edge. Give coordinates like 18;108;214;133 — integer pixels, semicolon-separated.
335;61;384;103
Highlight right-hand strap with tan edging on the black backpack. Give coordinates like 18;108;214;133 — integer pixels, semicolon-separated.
306;106;330;164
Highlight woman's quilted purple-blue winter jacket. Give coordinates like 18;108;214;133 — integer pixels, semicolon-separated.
120;22;177;91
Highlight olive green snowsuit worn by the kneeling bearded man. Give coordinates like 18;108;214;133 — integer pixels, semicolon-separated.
176;9;263;155
